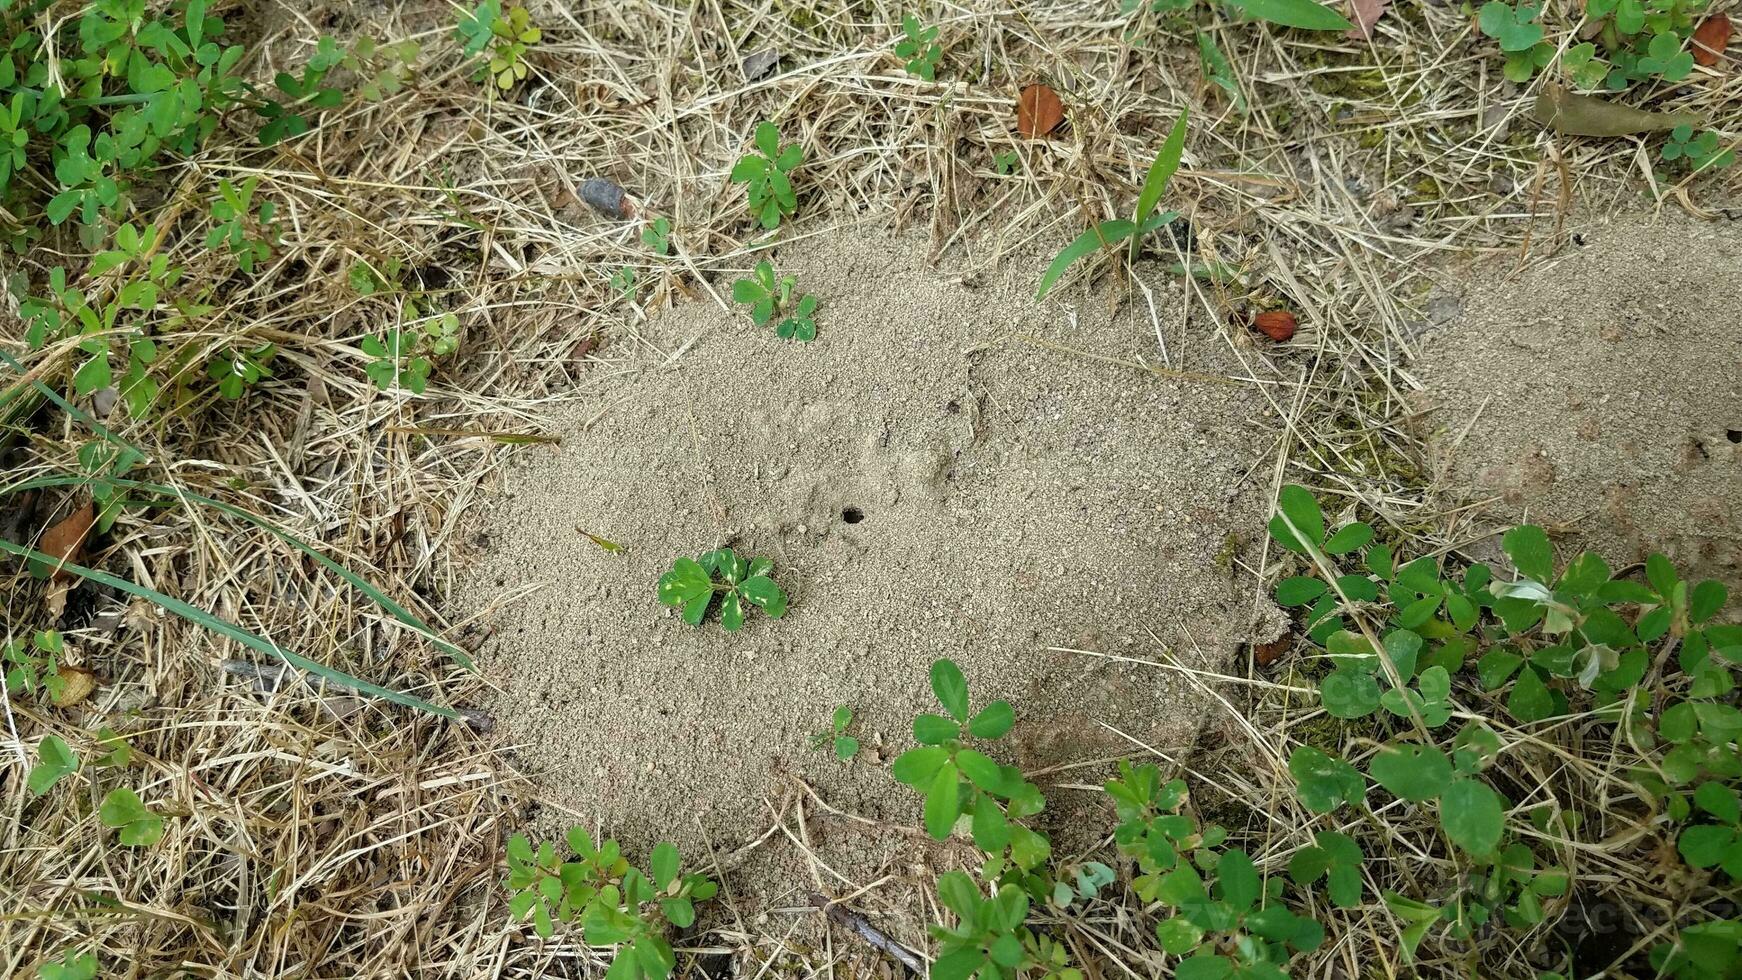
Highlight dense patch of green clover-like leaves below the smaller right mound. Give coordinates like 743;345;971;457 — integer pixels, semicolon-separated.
1270;487;1742;977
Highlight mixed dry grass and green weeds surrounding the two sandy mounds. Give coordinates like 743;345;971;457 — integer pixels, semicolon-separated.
0;0;1742;980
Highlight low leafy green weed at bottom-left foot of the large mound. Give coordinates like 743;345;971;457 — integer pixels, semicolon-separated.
503;827;718;980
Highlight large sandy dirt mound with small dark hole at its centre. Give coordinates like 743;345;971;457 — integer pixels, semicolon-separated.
458;237;1273;873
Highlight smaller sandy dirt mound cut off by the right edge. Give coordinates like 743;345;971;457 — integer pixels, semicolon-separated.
1418;214;1742;583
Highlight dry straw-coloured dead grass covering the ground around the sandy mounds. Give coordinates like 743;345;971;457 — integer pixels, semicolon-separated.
0;0;1742;977
